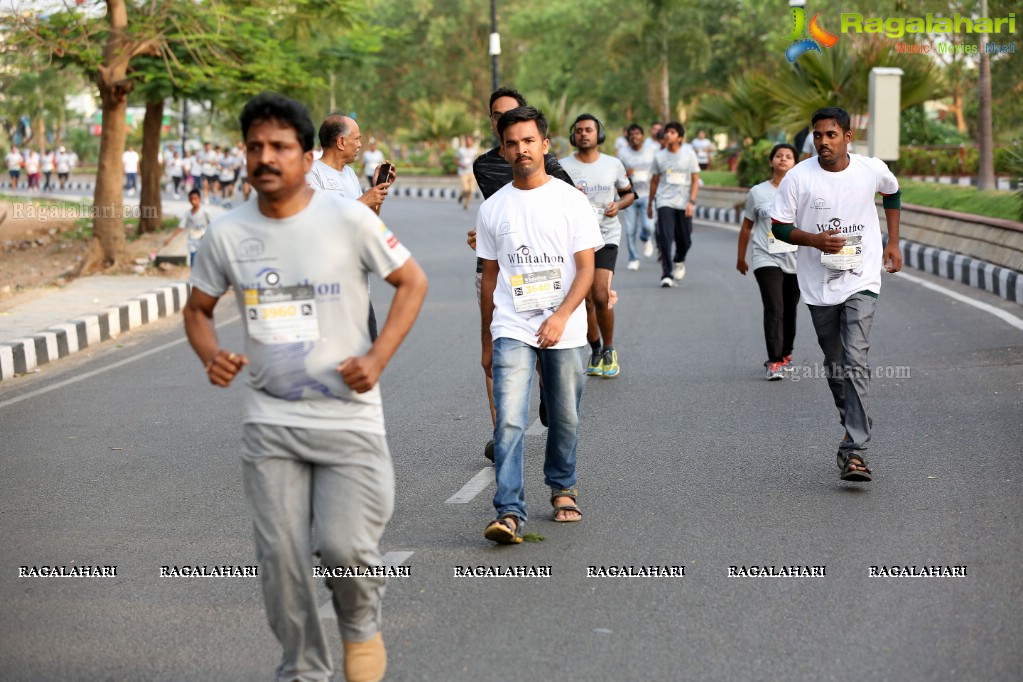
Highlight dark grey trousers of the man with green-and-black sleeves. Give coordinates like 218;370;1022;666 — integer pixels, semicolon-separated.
807;293;878;461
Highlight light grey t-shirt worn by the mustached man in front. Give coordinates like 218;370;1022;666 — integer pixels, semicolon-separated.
190;192;409;435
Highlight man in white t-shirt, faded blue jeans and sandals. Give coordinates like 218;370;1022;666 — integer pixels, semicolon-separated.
476;106;604;544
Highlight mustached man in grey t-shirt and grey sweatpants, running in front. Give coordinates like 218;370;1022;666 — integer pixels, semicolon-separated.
184;93;427;682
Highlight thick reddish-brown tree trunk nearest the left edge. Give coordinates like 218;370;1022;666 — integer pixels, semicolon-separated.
81;0;132;274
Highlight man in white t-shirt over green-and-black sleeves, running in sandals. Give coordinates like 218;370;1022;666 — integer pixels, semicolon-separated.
771;106;902;482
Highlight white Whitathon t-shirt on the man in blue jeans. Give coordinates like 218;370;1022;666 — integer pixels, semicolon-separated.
476;178;604;349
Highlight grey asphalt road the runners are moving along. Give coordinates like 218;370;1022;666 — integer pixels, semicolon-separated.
0;199;1023;682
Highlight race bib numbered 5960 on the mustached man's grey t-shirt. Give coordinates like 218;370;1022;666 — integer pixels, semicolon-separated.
244;286;319;344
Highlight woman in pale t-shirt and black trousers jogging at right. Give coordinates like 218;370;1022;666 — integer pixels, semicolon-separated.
736;144;799;381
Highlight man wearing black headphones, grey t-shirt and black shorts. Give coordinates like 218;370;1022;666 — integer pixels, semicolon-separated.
560;113;635;378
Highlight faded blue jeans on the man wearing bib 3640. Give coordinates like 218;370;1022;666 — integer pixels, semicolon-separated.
493;337;584;521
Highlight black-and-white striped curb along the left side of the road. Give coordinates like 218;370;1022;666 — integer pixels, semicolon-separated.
0;282;190;381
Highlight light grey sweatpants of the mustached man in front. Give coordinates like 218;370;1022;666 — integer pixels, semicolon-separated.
241;423;394;682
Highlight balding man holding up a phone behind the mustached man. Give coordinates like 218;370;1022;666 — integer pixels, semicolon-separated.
306;111;396;215
